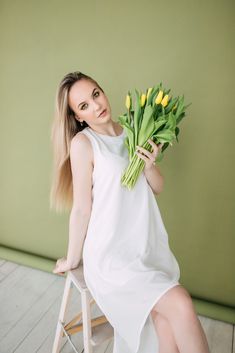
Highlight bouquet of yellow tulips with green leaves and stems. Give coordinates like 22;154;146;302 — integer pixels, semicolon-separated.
118;82;191;190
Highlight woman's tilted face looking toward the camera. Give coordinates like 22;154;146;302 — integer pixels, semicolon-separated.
68;79;111;127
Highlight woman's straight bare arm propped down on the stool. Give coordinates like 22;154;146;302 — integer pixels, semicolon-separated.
67;133;93;269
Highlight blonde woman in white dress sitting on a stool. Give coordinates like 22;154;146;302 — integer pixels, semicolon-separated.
51;72;209;353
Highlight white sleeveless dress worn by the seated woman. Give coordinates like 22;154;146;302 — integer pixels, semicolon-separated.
80;127;180;353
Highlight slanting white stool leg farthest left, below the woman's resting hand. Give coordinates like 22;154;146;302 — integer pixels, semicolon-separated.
52;274;71;353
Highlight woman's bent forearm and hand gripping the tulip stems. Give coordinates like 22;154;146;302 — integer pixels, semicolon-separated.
136;140;164;195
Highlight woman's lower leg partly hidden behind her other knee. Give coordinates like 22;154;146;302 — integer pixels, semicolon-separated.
151;310;179;353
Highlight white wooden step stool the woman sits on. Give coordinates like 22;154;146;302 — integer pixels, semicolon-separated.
52;262;114;353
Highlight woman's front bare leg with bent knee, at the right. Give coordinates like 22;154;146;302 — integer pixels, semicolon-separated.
152;285;210;353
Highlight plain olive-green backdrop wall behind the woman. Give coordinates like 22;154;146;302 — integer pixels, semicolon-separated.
0;0;235;320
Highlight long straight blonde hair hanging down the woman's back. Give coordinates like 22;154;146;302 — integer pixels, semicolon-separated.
50;71;104;212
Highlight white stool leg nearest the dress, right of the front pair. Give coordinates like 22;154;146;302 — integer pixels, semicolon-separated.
81;290;93;353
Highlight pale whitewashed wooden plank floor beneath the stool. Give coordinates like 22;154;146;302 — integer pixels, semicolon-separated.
0;259;235;353
